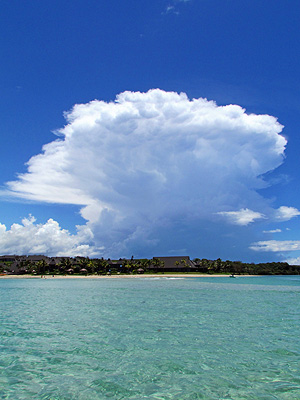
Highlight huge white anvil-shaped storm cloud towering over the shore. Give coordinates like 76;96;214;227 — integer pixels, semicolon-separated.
1;89;288;255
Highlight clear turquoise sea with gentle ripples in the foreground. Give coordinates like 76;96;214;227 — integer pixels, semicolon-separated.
0;276;300;400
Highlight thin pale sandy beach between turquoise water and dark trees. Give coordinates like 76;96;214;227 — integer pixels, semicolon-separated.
0;273;262;279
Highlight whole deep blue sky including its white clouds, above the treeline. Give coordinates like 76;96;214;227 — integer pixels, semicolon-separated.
0;0;300;262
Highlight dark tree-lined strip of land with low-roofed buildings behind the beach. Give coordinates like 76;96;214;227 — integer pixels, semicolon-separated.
0;255;300;276
